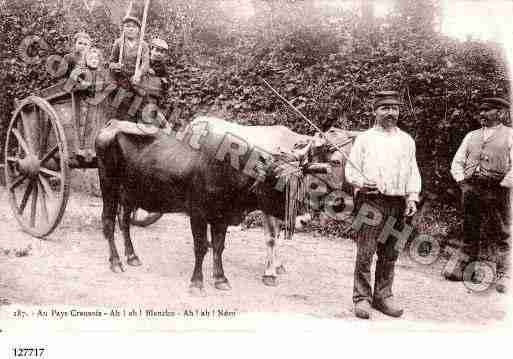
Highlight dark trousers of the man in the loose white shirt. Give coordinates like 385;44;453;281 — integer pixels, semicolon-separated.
353;193;405;303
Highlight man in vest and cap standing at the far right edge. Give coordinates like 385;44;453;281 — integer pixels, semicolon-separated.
444;98;513;293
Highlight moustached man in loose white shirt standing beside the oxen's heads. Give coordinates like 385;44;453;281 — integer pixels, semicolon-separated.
345;91;421;319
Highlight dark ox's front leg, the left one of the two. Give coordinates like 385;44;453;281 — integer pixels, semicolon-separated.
189;215;208;296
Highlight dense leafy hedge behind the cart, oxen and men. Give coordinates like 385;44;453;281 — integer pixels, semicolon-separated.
0;0;510;200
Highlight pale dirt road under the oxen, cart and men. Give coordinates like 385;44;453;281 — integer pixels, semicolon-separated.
0;189;506;330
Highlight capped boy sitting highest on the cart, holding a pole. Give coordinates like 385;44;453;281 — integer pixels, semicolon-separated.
109;16;150;89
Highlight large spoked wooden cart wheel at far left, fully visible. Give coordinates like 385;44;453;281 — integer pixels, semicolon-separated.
5;96;70;237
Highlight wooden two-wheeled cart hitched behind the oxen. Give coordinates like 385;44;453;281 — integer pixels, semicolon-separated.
4;72;161;237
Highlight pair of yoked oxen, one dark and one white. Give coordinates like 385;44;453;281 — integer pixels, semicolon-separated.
96;117;354;295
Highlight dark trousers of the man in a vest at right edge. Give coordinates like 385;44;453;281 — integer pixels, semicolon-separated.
462;179;511;273
